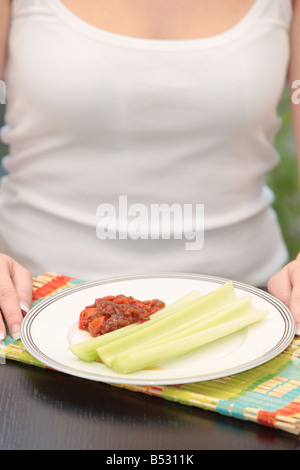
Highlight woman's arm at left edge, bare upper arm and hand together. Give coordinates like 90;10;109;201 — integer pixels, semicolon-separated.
0;0;32;341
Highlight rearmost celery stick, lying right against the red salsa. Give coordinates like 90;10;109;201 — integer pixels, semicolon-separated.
69;291;202;362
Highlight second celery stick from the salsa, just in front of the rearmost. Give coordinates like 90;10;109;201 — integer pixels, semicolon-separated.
97;282;237;366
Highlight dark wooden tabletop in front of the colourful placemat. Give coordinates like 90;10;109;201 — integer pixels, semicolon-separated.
0;360;300;455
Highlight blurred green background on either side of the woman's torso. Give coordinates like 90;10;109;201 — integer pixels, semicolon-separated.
0;90;300;259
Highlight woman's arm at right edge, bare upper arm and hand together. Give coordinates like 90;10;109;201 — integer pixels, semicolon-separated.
268;0;300;334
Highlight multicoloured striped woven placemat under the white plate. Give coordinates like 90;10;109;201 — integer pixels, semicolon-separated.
0;273;300;435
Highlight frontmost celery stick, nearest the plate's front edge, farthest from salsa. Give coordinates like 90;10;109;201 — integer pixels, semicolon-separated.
113;310;267;374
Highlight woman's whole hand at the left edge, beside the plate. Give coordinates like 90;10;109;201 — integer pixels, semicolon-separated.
0;253;32;341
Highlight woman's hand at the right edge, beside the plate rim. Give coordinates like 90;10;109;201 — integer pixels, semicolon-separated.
268;253;300;335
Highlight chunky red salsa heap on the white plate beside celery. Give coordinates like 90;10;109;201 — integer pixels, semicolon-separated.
79;295;165;337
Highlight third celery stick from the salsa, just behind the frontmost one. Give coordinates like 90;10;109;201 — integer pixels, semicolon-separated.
97;296;254;367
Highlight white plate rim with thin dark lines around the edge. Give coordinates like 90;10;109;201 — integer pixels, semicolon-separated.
21;272;296;386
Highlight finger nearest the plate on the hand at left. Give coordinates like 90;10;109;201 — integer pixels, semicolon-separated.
11;263;33;317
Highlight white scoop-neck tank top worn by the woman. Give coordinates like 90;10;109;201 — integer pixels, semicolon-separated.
0;0;292;285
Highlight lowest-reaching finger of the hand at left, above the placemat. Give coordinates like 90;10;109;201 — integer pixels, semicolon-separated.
0;271;23;339
